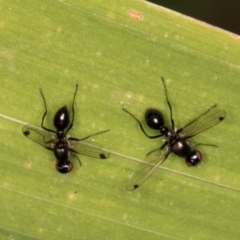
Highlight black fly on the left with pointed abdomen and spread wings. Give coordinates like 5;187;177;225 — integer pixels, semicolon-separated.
22;84;110;174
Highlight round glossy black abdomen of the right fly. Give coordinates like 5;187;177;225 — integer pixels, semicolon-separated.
145;109;164;130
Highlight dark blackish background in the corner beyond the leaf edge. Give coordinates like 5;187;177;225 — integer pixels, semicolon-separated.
148;0;240;34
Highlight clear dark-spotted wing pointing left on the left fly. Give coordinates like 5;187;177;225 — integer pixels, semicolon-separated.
22;125;56;150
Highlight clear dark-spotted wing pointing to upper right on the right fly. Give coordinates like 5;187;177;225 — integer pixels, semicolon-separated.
181;105;226;138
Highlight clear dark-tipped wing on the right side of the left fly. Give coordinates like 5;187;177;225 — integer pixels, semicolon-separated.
68;138;110;159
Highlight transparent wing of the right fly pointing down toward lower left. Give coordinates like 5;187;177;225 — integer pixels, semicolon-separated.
126;149;170;191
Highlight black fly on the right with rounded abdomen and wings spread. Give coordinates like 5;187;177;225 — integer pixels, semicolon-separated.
123;78;226;191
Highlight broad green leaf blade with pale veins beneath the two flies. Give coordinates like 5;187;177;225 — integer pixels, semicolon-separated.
0;0;240;240
